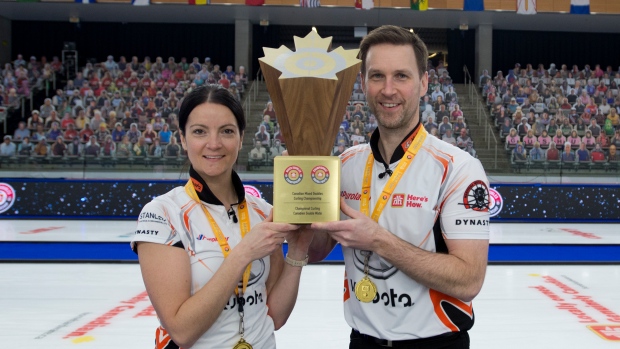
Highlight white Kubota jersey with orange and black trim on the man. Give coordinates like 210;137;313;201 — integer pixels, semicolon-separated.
340;128;489;340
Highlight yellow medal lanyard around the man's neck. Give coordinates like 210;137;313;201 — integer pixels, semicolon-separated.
360;127;428;222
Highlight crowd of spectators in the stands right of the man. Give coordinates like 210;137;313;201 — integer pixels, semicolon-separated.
479;64;620;168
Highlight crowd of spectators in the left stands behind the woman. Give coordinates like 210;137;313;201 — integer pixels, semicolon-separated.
0;56;247;163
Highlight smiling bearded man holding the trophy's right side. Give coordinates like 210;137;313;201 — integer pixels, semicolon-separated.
309;26;489;349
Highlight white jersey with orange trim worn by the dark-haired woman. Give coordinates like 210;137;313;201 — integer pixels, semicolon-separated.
131;187;275;349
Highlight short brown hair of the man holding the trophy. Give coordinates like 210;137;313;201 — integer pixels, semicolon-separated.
359;25;428;77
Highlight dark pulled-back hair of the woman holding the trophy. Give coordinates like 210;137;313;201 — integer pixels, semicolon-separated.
179;86;245;135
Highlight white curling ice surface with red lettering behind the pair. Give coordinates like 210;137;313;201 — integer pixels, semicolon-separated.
0;220;620;349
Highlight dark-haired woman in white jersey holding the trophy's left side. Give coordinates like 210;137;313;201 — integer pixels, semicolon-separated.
132;87;312;349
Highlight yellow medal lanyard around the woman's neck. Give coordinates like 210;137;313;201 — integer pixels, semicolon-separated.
185;179;252;296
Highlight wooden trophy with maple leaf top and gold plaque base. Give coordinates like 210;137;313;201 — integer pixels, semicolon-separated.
259;31;361;224
